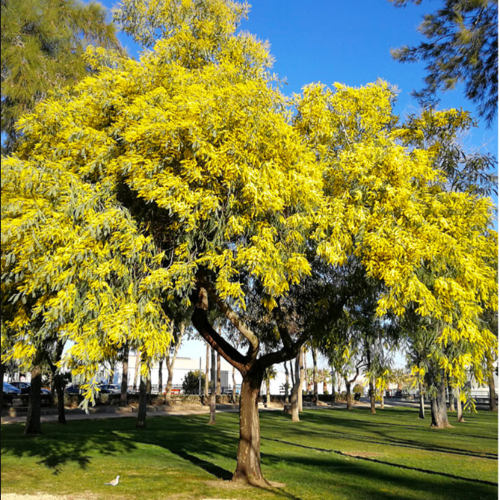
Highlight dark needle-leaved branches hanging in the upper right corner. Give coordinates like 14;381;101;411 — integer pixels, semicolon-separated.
389;0;500;124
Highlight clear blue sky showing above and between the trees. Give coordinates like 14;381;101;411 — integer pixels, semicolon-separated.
96;0;498;364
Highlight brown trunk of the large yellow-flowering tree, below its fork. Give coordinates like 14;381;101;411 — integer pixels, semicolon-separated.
233;370;269;487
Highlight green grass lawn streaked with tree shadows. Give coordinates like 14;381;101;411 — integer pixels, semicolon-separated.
2;408;499;500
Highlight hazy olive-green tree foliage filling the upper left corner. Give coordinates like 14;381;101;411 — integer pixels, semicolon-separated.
1;0;120;150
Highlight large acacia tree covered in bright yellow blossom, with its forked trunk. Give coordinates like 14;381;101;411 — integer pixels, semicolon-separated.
2;0;497;485
